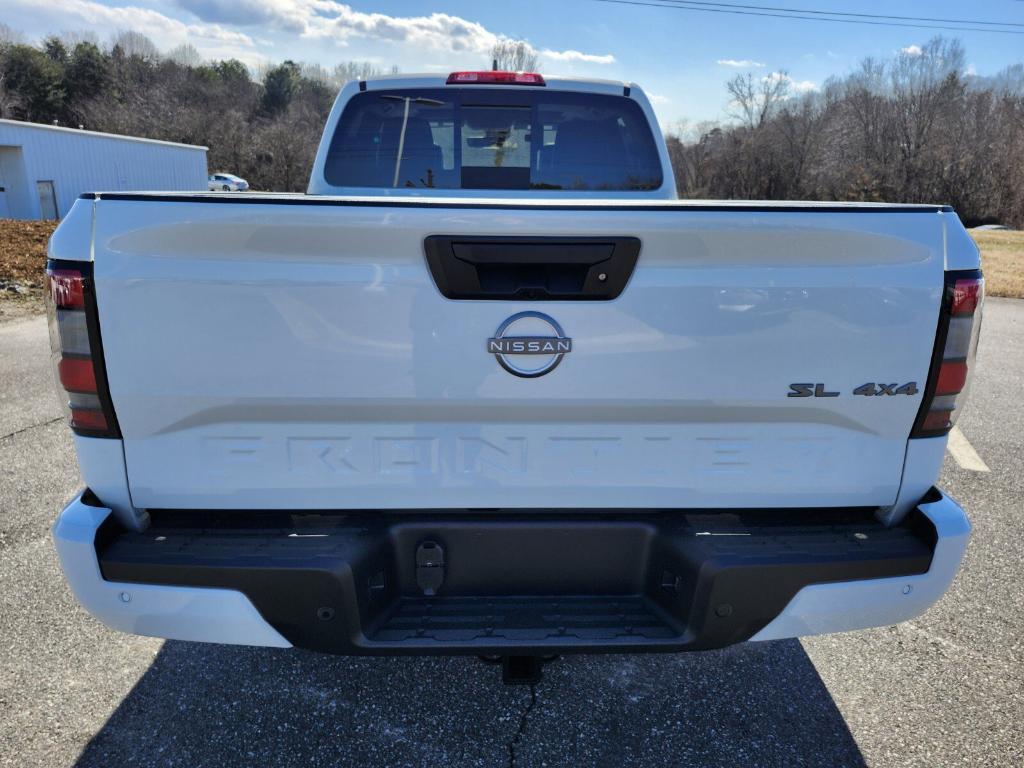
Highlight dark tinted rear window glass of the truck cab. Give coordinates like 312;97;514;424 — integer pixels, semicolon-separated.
324;88;662;191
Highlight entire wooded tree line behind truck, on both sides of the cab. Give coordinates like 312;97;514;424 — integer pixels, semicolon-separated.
0;26;1024;226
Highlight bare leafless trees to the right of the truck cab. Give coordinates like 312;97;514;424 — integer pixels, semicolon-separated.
667;38;1024;227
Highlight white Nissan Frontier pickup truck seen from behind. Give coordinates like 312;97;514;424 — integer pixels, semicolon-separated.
49;73;983;679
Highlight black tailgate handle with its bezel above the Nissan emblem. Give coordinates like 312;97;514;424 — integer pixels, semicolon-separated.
424;234;640;301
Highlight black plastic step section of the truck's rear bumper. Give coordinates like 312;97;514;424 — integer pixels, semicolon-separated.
96;509;935;654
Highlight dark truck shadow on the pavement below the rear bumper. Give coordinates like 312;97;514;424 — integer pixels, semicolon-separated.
77;640;864;768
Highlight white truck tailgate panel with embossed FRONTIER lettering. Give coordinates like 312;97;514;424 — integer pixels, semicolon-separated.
94;196;946;509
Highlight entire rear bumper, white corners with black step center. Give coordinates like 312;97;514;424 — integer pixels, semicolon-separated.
54;490;970;654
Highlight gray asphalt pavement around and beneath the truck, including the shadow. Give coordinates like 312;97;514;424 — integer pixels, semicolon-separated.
0;299;1024;768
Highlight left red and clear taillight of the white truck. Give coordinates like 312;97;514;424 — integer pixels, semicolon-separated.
46;259;121;437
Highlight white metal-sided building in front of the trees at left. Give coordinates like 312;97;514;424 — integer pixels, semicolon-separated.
0;120;207;219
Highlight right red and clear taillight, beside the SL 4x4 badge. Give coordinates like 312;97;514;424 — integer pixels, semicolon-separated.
910;269;985;437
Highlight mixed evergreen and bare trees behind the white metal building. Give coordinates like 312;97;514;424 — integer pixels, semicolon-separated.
0;30;383;191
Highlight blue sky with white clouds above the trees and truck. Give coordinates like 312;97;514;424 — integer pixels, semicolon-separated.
0;0;1024;124
